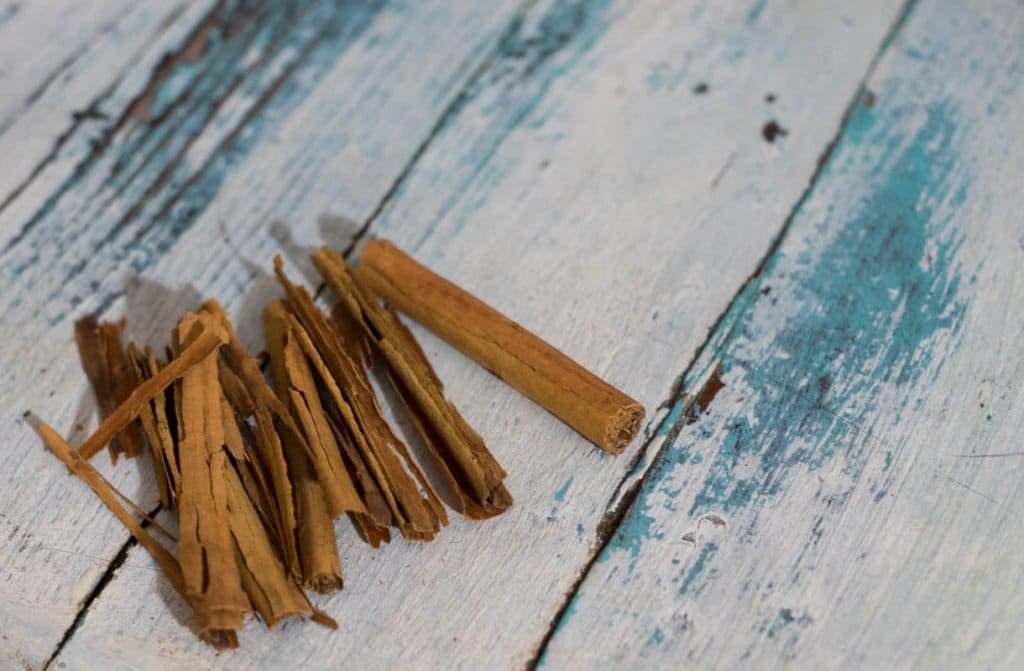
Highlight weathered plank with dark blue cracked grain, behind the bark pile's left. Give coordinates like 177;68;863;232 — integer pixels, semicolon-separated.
0;0;518;667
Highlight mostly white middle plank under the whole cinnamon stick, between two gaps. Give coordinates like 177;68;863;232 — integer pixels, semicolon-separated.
54;0;897;669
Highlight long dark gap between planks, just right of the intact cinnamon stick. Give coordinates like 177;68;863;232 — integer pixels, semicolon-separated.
525;0;921;671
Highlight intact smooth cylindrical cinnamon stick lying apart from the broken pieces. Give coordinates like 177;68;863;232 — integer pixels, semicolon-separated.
358;240;644;454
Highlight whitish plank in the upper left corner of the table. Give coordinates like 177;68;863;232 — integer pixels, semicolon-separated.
0;0;213;220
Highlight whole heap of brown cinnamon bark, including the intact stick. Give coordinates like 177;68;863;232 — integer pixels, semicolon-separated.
37;243;643;647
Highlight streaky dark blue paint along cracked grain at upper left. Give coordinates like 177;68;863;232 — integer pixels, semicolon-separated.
0;2;381;325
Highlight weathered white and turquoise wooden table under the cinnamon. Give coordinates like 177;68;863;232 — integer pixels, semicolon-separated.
0;0;1024;671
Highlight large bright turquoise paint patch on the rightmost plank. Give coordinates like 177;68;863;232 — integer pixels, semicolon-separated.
691;99;969;512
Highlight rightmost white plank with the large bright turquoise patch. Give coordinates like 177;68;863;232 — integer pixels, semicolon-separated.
544;0;1024;669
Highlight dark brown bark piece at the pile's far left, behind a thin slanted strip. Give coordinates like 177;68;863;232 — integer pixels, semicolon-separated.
75;314;143;463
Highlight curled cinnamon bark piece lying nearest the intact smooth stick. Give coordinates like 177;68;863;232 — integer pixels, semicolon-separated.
313;248;512;518
